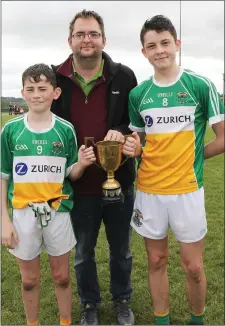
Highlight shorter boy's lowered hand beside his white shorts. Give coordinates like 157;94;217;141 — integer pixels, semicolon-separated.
2;218;19;249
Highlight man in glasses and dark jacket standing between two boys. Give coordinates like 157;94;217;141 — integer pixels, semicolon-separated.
52;10;137;325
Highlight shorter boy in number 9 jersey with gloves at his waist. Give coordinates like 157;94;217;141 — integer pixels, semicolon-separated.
1;64;95;325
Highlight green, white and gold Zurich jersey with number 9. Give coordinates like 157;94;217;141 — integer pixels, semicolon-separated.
1;114;77;212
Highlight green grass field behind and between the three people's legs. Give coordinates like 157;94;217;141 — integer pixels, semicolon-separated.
1;115;224;325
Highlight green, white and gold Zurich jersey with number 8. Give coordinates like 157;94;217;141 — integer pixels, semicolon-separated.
129;69;224;194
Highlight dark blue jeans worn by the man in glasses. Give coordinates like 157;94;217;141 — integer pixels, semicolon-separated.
71;187;134;305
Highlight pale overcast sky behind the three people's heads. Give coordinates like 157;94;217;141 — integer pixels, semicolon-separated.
1;1;224;97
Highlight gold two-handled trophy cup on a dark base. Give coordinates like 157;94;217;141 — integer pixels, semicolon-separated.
84;135;130;204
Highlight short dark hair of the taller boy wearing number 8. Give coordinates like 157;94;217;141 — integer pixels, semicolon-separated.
140;15;177;46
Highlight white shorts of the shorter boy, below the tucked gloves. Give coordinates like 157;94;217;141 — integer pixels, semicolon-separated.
9;207;76;260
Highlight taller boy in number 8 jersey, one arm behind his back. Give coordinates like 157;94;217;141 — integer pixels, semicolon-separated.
124;15;224;325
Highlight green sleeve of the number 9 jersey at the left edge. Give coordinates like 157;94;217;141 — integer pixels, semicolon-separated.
1;126;13;180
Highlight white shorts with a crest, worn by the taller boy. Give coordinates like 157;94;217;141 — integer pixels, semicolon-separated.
131;187;207;243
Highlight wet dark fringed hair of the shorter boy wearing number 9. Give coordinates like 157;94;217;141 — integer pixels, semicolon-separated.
22;63;57;89
